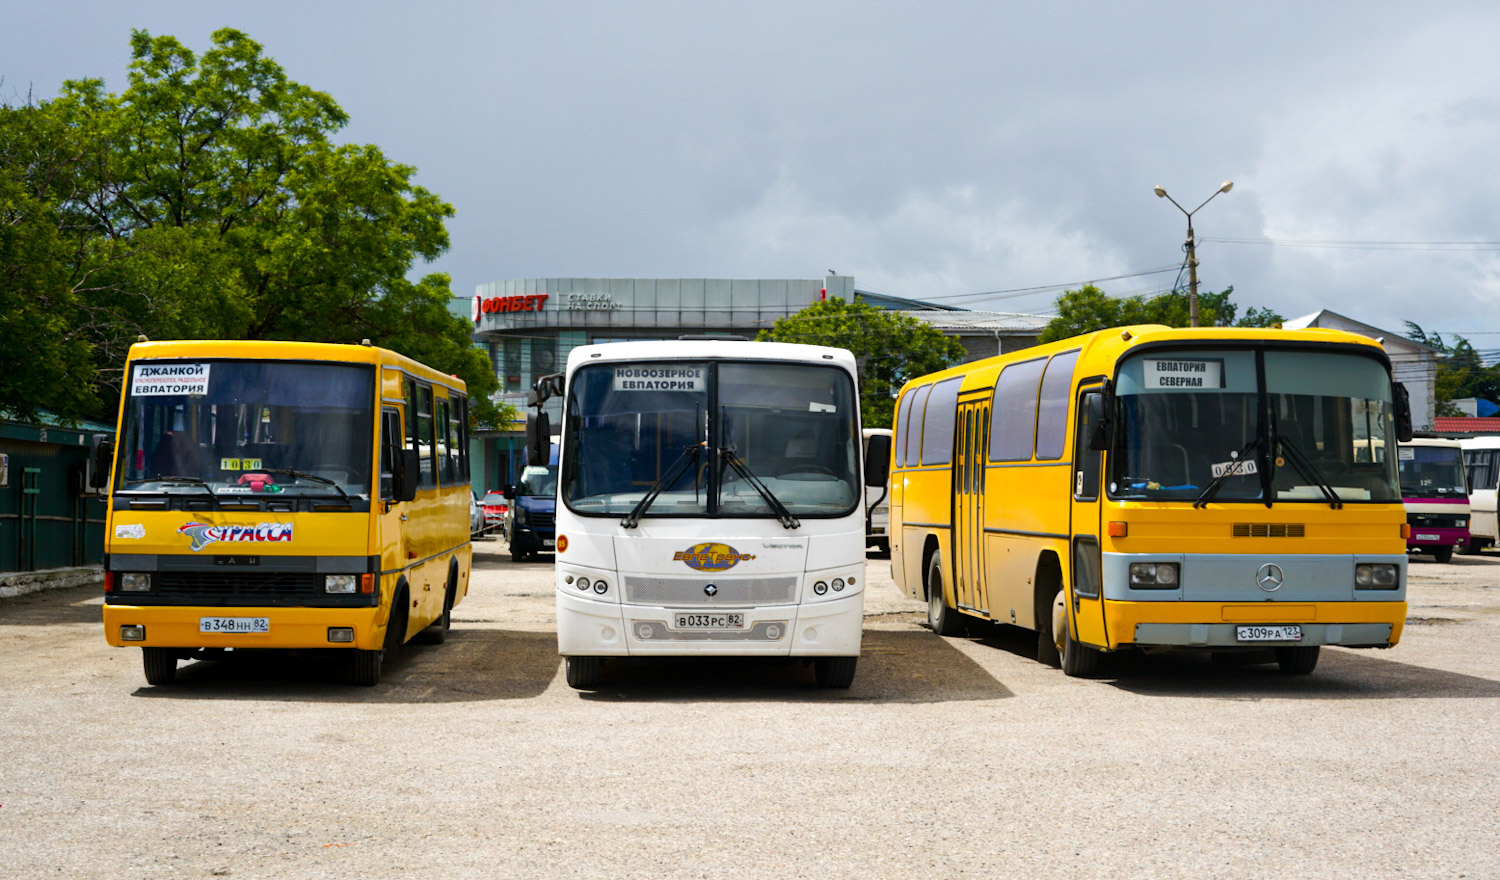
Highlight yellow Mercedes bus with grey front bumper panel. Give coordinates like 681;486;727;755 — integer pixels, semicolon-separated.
891;325;1410;675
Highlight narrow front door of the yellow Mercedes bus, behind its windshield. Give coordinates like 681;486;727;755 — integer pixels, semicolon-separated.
1068;385;1109;648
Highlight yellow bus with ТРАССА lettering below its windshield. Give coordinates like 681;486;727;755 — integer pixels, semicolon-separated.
95;340;470;685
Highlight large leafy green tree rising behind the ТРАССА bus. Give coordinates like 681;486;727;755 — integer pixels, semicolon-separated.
0;28;500;421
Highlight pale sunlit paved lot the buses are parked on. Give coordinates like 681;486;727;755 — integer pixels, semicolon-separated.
0;541;1500;880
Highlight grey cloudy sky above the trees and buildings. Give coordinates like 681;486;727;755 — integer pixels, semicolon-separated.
0;0;1500;349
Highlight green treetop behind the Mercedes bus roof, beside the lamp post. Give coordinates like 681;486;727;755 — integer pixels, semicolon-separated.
1040;285;1284;342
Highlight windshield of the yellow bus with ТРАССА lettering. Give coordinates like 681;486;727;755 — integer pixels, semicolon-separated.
116;360;375;496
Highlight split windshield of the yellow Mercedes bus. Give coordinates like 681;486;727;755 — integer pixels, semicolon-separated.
1110;349;1401;502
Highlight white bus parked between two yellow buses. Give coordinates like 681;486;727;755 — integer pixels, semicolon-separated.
540;339;890;688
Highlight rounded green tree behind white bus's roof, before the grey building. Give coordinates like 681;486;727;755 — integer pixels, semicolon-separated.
756;297;963;427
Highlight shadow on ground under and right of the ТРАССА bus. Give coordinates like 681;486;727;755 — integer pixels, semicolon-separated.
135;630;560;703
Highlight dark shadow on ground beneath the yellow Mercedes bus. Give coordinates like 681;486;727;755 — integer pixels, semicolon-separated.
1097;648;1500;700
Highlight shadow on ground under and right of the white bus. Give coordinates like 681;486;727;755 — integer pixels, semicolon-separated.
579;630;1014;703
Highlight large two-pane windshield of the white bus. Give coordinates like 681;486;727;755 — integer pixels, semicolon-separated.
561;361;861;517
